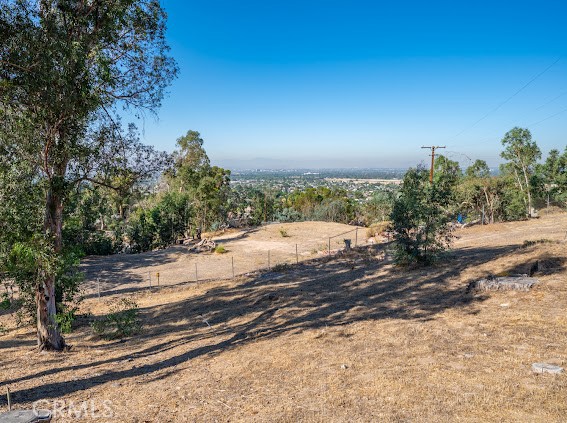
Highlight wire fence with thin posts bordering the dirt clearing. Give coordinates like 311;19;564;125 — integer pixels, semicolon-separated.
83;227;373;298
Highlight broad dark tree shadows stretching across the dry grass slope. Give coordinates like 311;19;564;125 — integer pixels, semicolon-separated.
5;246;515;402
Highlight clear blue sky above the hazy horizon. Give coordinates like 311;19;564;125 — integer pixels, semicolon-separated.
131;0;567;168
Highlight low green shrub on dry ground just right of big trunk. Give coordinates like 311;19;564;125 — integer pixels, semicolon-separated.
91;298;142;340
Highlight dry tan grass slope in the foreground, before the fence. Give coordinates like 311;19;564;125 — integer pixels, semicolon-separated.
0;214;567;422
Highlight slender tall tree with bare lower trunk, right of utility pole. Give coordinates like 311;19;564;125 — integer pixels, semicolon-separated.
500;127;541;217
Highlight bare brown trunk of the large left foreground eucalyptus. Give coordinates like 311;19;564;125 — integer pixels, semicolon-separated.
35;186;65;351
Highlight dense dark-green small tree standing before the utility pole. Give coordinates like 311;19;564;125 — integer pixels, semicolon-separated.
391;167;452;264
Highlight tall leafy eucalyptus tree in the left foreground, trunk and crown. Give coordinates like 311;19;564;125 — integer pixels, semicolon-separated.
0;0;177;350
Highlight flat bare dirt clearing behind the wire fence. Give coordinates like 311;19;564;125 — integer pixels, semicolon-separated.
81;222;367;296
